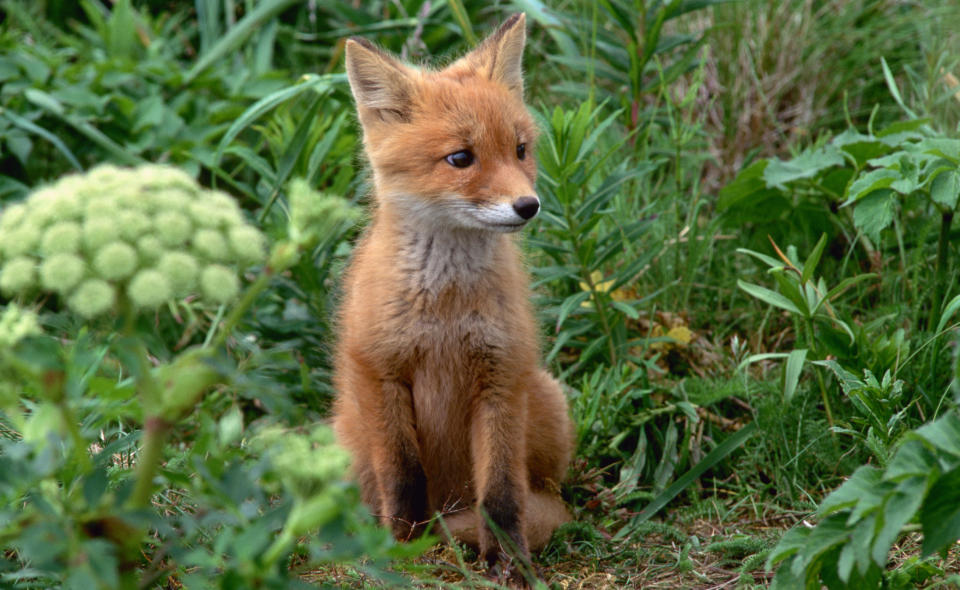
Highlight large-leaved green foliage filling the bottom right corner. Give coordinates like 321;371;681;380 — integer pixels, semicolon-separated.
767;410;960;589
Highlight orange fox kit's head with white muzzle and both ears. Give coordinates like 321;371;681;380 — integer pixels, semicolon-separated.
346;14;540;232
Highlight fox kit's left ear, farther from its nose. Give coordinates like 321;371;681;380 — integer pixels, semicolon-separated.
346;37;413;120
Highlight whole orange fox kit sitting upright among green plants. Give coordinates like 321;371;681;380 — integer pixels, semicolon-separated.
334;14;572;567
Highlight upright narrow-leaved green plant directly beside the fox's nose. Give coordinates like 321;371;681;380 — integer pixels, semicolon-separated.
528;103;655;370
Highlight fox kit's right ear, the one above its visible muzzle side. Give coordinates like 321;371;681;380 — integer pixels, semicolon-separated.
463;12;527;97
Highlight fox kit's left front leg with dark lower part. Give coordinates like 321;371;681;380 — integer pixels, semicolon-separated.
374;381;427;541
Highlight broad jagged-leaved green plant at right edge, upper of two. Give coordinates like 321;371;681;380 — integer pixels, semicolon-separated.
719;119;960;327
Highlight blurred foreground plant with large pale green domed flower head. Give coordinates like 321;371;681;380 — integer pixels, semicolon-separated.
0;167;404;588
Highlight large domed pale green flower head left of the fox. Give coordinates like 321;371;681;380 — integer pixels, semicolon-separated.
0;165;266;318
